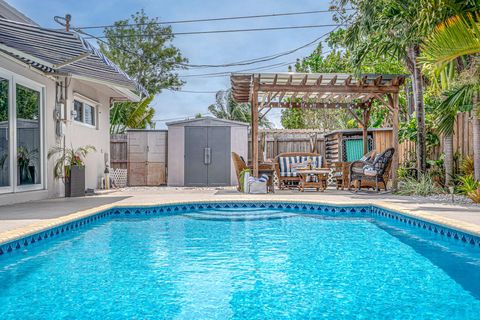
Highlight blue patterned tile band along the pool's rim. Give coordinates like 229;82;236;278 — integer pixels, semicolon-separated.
0;200;480;257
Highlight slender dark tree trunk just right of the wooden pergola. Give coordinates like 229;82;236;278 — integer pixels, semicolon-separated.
408;45;427;173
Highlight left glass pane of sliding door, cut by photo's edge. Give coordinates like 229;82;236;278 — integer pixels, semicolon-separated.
0;77;10;187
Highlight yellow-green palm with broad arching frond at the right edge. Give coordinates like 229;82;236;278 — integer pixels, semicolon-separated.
422;14;480;180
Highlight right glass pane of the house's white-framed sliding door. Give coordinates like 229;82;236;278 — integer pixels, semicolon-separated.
16;84;42;185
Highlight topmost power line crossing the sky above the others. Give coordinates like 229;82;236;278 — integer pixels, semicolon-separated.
74;9;353;30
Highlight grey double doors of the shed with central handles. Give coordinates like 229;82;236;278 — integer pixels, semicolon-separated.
185;127;230;186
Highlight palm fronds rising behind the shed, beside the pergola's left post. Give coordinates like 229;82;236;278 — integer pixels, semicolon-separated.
208;90;272;128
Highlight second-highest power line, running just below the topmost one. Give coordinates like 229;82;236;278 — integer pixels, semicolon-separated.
83;24;344;39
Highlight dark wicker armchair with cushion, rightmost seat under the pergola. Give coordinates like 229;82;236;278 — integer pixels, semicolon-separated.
350;148;395;192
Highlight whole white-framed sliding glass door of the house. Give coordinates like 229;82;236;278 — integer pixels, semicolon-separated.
0;70;45;193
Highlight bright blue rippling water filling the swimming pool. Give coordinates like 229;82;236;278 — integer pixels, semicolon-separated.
0;208;480;319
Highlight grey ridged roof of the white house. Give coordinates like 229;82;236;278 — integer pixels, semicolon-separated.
0;19;147;99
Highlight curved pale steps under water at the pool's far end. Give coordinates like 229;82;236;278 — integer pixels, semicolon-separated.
183;210;297;221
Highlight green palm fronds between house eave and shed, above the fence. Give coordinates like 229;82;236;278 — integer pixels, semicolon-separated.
110;95;155;134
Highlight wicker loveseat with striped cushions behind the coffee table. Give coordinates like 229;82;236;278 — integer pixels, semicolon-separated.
274;152;323;189
